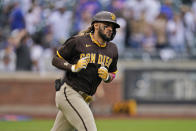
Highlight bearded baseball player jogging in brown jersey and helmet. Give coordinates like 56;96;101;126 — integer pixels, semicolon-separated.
51;11;120;131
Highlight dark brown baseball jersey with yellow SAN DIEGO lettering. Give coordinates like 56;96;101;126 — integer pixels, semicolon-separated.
57;34;118;95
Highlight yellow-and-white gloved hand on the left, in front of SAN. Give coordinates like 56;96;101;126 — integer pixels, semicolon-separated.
71;57;90;72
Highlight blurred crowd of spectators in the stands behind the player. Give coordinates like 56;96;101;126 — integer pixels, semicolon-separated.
0;0;196;72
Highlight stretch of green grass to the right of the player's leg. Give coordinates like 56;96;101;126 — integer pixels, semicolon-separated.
97;120;196;131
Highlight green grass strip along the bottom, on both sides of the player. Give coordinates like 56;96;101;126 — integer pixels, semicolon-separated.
0;119;196;131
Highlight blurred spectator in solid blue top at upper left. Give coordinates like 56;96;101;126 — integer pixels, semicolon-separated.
9;1;25;30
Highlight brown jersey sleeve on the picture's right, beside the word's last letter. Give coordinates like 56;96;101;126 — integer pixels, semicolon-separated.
108;46;118;74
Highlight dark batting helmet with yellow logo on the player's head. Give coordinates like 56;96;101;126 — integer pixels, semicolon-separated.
91;11;120;28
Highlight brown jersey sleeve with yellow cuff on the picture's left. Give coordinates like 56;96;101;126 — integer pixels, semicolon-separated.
57;38;76;62
